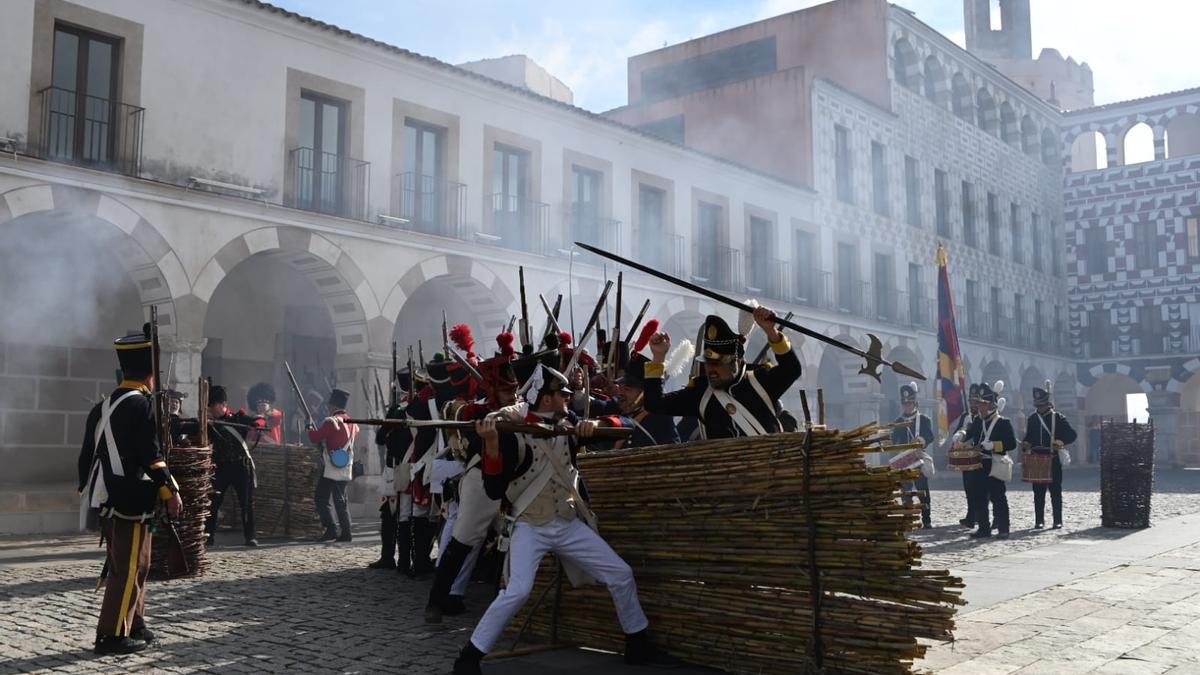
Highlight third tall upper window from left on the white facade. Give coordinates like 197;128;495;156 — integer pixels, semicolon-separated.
400;119;448;233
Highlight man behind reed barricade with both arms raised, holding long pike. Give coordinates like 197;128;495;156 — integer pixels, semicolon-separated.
644;307;800;438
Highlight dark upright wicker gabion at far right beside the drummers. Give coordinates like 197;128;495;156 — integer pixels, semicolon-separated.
1100;422;1154;528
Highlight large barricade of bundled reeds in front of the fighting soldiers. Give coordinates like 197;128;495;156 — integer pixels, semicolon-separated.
505;426;964;675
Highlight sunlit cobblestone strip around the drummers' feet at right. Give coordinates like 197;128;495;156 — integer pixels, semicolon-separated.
912;467;1200;569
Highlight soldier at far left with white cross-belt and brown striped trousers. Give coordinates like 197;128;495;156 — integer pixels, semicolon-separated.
79;330;184;653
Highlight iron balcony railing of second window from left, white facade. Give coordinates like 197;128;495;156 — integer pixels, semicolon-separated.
287;148;371;220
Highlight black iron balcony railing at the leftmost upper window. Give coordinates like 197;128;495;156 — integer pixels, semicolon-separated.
35;86;145;175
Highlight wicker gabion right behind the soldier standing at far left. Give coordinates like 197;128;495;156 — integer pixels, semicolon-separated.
150;447;212;579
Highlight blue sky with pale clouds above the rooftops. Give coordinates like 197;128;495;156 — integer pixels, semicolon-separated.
270;0;1200;110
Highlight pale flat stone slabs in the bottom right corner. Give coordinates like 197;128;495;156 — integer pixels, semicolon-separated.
918;544;1200;675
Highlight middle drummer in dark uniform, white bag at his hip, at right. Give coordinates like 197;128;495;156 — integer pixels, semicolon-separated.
956;381;1016;539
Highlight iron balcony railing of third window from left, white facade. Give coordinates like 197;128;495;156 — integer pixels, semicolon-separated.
385;172;467;239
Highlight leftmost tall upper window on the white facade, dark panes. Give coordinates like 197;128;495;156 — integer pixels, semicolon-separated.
44;25;119;166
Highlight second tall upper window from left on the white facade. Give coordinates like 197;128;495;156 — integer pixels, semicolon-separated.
296;91;349;214
